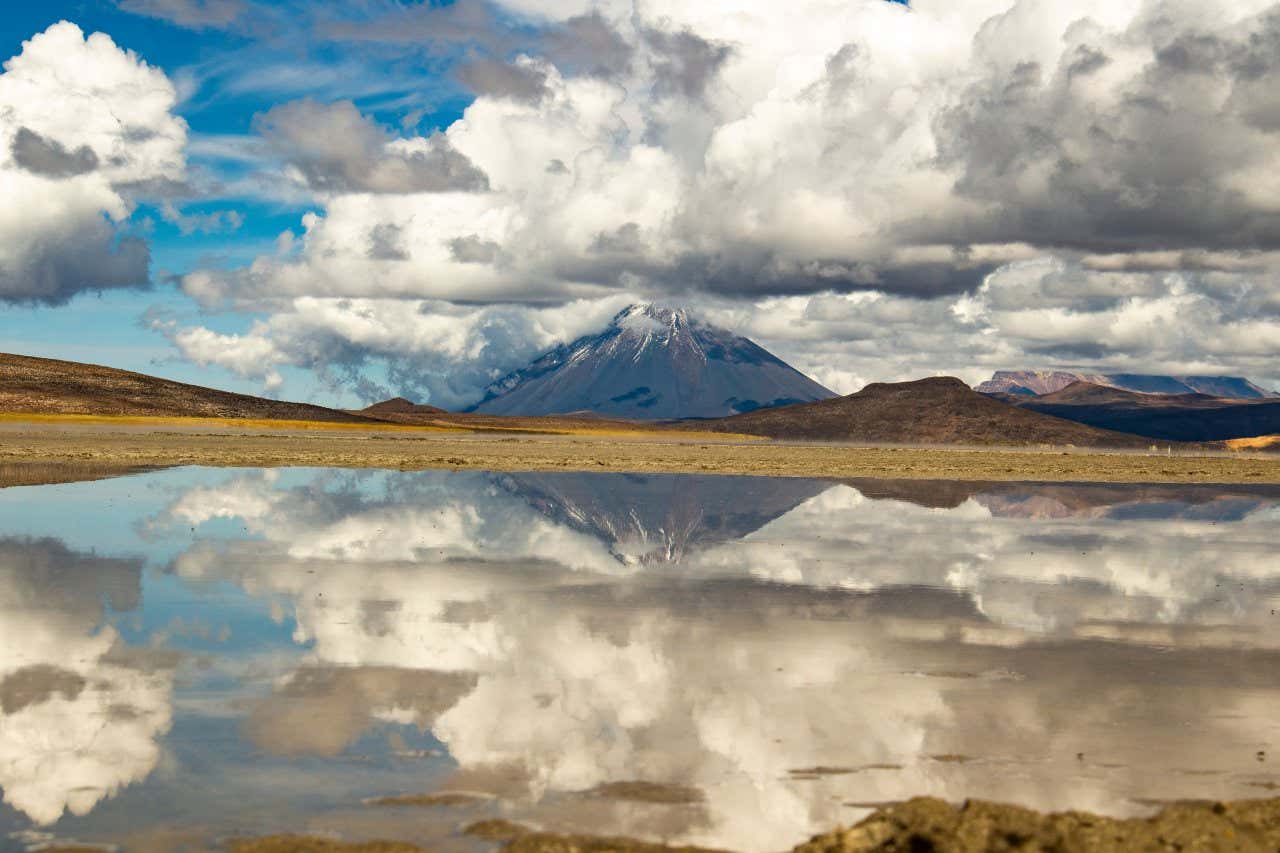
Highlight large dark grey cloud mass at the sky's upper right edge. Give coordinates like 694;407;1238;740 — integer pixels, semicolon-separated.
919;9;1280;252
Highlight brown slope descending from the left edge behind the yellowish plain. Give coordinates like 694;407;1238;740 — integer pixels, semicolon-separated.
0;353;376;423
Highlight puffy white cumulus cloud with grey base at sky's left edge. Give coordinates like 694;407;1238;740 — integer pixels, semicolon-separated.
0;20;187;304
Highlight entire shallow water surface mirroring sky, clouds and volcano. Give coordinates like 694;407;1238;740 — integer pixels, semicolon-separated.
0;469;1280;850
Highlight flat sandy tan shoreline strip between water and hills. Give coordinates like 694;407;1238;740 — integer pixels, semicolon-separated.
0;420;1280;485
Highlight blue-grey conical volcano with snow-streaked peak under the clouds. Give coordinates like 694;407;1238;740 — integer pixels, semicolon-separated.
470;305;836;420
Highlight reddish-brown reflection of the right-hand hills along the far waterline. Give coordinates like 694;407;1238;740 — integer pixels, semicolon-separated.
846;479;1280;521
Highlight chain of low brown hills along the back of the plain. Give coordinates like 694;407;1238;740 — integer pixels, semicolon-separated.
0;353;1249;450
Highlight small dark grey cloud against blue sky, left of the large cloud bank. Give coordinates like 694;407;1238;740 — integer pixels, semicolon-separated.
253;99;489;193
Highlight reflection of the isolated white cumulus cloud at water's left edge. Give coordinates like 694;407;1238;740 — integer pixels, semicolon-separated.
0;538;172;824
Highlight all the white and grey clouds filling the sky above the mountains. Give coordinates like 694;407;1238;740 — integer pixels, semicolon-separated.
0;0;1280;406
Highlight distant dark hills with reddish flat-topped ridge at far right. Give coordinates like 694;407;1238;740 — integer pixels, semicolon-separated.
1006;382;1280;442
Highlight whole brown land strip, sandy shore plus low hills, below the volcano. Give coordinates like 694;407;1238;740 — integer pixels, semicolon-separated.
0;355;1280;485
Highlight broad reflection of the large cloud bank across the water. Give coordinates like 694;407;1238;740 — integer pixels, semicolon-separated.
147;474;1280;849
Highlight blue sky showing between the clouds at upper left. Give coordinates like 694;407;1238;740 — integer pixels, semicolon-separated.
0;0;472;402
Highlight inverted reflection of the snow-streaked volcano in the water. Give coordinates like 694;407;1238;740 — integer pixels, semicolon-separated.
497;473;831;564
